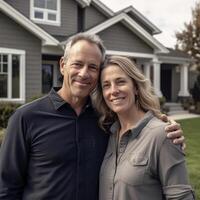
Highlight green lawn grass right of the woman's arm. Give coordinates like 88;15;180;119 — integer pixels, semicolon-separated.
178;118;200;200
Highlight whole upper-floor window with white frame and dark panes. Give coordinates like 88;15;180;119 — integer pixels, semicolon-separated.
30;0;61;26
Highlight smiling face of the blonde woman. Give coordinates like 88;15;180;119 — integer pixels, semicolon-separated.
101;65;137;114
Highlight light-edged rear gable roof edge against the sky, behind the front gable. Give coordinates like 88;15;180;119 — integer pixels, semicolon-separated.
117;6;161;34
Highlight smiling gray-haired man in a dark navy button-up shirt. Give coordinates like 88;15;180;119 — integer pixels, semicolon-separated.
0;33;183;200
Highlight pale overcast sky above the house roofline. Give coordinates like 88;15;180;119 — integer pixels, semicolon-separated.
101;0;200;48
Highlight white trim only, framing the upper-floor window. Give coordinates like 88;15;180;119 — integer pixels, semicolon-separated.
30;0;61;26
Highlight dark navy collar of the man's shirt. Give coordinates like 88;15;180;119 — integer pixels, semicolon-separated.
49;87;92;110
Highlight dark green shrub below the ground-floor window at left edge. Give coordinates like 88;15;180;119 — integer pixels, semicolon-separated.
0;102;21;128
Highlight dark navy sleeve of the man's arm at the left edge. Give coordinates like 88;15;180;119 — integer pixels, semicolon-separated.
0;112;28;200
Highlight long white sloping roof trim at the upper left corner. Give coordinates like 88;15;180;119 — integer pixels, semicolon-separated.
0;0;59;46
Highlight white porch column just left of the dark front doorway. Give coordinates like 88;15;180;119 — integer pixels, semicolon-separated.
152;59;163;97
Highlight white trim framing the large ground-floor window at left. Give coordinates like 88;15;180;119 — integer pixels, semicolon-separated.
0;48;26;103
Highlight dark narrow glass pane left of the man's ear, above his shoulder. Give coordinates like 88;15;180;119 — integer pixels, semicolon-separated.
42;65;53;94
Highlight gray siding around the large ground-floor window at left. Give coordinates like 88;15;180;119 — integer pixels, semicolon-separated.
0;12;41;99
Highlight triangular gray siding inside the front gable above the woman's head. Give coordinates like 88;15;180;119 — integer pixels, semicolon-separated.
99;23;153;54
